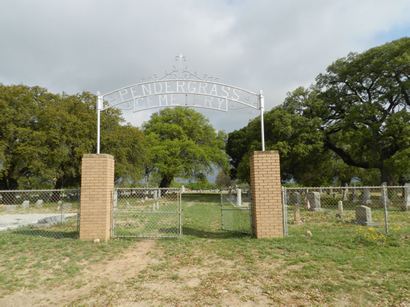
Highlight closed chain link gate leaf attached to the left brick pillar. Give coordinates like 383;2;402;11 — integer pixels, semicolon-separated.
112;188;182;238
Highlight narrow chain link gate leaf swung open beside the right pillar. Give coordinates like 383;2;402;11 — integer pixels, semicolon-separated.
221;189;252;234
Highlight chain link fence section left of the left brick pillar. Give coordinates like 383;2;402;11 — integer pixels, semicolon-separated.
0;189;80;238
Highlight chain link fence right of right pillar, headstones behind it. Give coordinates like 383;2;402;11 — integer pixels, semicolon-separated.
283;185;410;235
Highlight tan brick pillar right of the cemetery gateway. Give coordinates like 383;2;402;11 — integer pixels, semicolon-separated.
250;151;283;238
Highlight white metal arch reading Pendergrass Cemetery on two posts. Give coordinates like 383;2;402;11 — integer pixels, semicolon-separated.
97;55;265;154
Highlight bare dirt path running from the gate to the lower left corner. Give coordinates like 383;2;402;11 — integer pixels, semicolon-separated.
0;241;155;306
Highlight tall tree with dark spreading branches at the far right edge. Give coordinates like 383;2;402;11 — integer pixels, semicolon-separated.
314;38;410;184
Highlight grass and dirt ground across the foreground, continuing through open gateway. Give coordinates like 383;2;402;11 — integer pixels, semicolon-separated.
0;194;410;306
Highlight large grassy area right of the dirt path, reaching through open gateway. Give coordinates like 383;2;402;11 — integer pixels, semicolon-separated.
128;199;410;305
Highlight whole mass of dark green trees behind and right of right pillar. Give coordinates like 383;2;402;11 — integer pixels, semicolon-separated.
227;38;410;185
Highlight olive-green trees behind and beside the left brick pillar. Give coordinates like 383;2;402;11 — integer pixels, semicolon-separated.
0;85;145;189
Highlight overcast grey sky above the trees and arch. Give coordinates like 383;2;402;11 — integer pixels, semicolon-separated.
0;0;410;131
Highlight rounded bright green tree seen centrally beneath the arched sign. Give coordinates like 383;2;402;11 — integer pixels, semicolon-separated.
144;107;227;187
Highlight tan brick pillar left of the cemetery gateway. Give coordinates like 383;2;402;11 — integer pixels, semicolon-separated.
80;154;114;241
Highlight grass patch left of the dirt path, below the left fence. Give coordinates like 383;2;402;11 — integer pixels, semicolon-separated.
0;222;131;296
